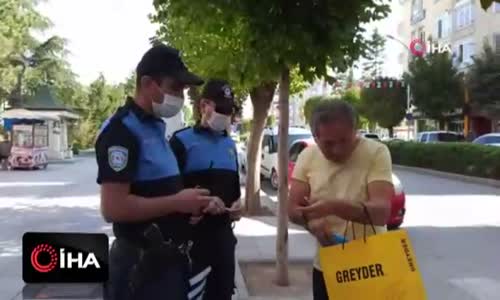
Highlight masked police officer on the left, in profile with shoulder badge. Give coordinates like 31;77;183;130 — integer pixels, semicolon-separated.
95;44;213;300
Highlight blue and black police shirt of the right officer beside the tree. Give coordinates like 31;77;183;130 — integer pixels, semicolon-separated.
170;125;241;228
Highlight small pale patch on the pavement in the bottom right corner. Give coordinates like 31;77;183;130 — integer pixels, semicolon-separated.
450;277;500;300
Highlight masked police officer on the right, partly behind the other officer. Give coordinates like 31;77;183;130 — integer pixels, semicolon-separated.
170;80;241;300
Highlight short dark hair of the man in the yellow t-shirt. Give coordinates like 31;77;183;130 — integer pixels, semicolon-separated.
311;99;358;136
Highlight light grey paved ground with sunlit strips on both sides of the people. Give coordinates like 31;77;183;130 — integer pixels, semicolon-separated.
0;157;500;300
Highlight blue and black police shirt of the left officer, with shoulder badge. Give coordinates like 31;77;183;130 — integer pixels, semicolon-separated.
95;99;189;240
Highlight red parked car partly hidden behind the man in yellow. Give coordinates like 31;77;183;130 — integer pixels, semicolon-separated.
288;139;406;230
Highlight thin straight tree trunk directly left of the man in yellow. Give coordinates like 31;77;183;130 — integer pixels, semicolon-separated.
276;67;290;286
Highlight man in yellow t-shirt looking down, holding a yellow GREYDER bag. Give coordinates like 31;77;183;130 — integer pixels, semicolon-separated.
289;100;393;300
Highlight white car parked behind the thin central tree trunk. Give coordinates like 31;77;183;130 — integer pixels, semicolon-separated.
260;127;312;189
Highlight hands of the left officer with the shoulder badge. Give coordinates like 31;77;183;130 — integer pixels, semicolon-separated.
176;189;213;215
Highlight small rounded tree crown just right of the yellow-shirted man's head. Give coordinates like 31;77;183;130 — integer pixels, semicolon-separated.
358;77;407;137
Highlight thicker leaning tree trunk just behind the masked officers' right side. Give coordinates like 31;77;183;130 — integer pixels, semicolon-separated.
245;82;276;215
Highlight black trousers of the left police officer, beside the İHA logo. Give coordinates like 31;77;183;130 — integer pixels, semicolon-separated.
104;239;189;300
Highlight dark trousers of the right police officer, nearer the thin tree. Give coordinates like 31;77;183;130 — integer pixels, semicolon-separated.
192;224;237;300
